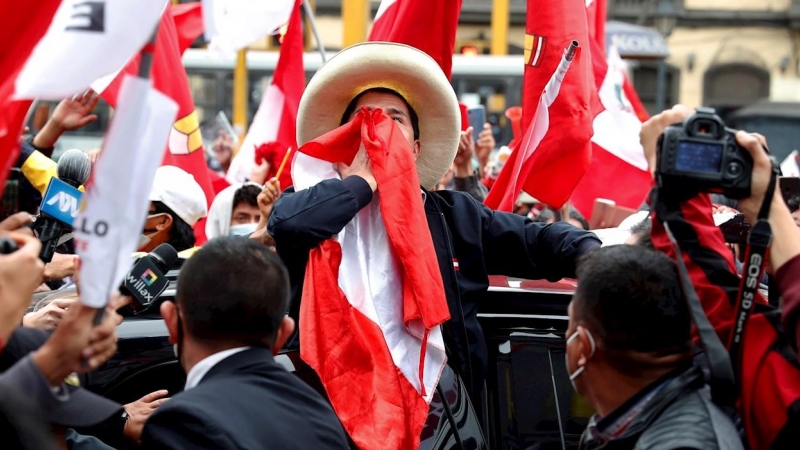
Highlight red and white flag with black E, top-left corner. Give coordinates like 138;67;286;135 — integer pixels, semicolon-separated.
0;0;167;189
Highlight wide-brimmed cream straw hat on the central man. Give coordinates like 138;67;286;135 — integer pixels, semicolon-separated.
297;42;461;188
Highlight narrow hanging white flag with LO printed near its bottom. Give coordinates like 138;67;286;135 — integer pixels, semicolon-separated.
75;76;178;308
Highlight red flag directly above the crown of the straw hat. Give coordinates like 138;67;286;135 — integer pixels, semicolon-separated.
369;0;461;78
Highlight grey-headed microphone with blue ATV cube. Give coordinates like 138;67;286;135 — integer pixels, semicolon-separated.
35;149;92;263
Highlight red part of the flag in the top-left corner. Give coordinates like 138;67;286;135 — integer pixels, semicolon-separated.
0;0;61;191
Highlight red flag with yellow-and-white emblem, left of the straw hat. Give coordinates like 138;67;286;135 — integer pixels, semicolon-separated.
101;6;214;245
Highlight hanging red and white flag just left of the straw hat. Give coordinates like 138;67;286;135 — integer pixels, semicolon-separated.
226;0;305;189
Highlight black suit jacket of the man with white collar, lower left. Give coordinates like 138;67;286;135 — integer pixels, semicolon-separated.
142;348;348;450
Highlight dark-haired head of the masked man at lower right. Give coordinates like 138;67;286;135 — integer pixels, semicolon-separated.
567;245;691;401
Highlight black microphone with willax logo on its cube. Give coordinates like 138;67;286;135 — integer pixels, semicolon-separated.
119;244;178;313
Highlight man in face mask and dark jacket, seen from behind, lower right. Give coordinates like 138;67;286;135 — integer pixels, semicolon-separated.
566;245;743;450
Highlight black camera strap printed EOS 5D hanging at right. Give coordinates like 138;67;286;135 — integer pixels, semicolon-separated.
728;170;778;373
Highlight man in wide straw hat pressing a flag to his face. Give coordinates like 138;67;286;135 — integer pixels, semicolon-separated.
269;42;600;448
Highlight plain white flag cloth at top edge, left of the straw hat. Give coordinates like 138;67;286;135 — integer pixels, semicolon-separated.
203;0;295;54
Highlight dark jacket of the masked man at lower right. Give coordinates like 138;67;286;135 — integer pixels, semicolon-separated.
580;367;744;450
